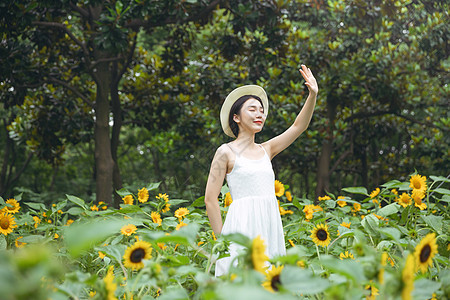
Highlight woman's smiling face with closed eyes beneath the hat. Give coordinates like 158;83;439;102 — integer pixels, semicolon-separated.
233;98;266;133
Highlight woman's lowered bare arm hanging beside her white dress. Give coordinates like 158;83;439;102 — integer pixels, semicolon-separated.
205;145;228;235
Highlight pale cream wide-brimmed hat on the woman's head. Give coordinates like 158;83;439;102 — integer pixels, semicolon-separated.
220;85;269;138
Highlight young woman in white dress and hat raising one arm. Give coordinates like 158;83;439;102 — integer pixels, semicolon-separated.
205;65;318;276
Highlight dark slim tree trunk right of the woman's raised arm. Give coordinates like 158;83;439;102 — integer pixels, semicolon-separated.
316;99;337;198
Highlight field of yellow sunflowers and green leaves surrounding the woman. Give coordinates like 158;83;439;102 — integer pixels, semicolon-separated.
0;173;450;300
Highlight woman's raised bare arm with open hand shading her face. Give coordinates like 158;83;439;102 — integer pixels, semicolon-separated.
263;65;319;158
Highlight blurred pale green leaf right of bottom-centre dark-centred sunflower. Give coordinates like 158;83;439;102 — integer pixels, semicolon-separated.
280;266;330;295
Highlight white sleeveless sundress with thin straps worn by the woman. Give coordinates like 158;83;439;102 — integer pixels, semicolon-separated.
215;145;286;276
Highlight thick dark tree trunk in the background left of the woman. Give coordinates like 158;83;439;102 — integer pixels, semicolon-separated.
94;57;114;205
